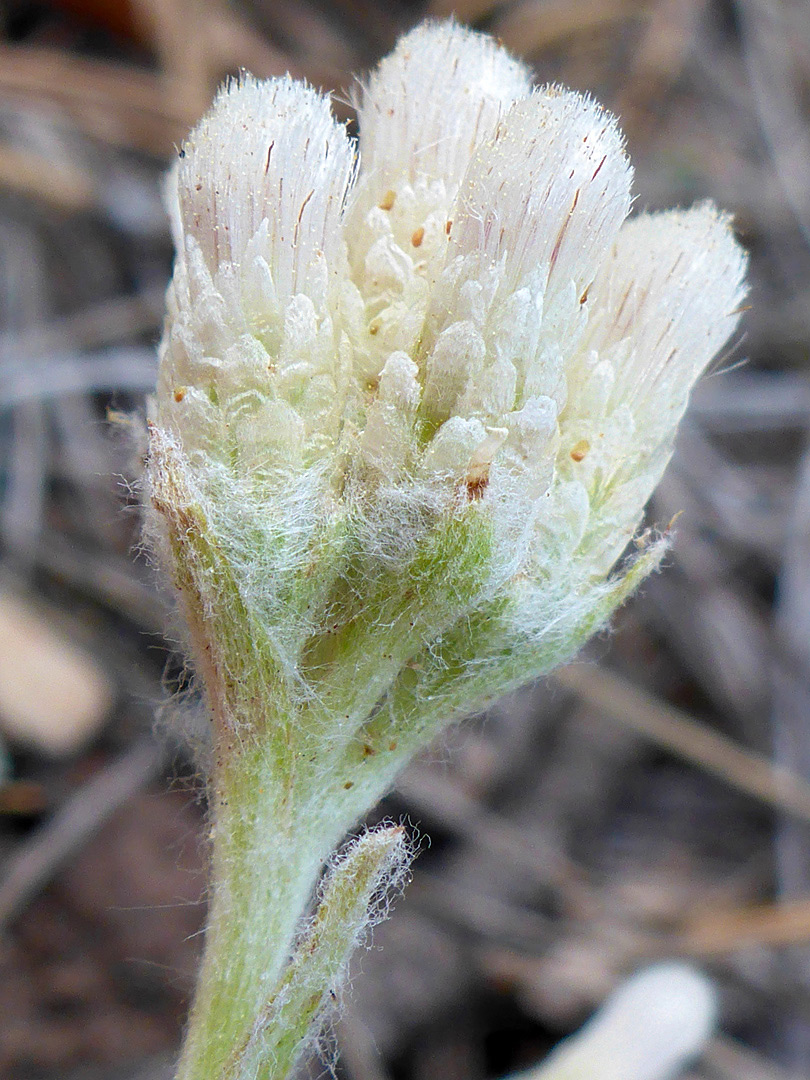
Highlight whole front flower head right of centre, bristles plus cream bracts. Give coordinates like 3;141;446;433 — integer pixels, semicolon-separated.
422;89;632;422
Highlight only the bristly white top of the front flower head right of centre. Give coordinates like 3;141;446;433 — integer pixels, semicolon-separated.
450;86;632;298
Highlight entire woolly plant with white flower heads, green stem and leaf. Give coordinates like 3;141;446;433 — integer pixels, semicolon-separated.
147;23;745;1080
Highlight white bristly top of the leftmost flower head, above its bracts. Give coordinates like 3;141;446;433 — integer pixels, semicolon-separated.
177;76;354;302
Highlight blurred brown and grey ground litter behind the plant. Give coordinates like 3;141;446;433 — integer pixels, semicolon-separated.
0;0;810;1080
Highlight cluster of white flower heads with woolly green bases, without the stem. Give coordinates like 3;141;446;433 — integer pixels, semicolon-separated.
152;23;745;734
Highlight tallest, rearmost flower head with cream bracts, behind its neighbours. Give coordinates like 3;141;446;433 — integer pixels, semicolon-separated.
347;23;530;376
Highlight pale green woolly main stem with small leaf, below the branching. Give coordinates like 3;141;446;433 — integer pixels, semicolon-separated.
177;746;403;1080
